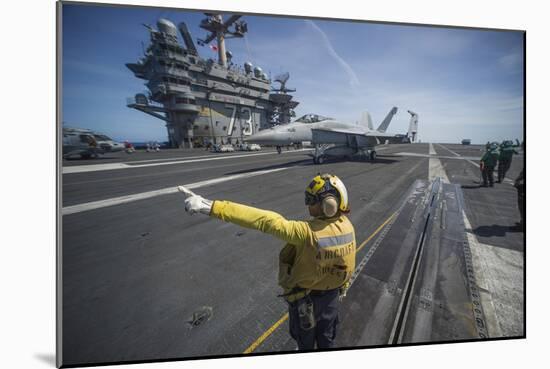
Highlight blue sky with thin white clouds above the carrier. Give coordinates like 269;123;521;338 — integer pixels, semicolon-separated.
62;4;524;143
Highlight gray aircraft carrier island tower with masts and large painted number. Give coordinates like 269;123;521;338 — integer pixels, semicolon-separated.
126;14;298;147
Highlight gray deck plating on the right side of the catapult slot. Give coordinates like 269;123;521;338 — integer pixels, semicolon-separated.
400;184;487;343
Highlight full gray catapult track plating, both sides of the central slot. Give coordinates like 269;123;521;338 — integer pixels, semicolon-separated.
338;177;487;347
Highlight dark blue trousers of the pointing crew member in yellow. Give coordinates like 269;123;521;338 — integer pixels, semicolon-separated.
288;288;340;350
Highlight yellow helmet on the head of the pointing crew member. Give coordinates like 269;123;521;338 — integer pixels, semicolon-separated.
306;174;349;213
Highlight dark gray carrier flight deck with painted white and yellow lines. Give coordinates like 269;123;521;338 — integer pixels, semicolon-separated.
61;143;524;365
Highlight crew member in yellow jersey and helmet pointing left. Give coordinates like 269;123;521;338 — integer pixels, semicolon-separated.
179;174;355;350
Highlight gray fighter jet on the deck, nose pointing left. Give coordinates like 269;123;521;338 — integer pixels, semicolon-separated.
245;107;418;164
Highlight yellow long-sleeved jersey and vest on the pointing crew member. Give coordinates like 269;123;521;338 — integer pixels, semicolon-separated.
210;200;355;302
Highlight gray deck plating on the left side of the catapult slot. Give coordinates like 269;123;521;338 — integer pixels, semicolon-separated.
337;181;436;347
